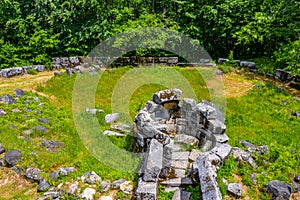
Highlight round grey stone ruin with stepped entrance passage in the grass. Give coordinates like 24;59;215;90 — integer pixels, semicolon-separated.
134;89;231;200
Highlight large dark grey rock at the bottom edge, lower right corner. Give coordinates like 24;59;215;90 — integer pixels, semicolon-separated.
264;180;292;200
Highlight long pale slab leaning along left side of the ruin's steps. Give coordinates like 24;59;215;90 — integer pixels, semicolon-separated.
143;139;163;181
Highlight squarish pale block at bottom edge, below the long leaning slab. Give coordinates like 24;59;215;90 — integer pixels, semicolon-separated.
134;178;157;200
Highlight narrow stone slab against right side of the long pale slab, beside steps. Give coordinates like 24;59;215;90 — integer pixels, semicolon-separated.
159;140;174;178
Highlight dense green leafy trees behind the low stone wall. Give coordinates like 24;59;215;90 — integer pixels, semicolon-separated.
0;0;300;74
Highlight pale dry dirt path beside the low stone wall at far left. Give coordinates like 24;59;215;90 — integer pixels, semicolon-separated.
0;71;61;95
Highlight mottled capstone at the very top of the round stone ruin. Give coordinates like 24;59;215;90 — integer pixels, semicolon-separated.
153;89;182;104
